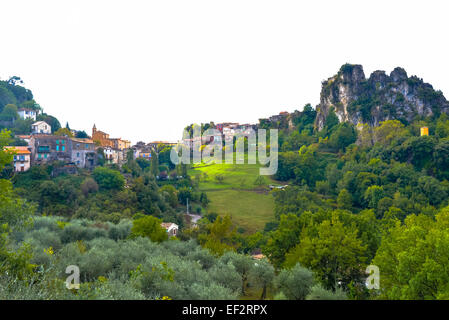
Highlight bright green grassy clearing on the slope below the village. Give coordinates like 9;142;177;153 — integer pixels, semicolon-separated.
189;159;278;233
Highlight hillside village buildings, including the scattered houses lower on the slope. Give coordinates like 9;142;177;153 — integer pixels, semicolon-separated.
4;99;289;236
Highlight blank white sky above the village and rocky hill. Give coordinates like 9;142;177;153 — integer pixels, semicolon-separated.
0;0;449;143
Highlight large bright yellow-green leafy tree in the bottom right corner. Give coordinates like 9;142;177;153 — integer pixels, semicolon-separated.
372;207;449;300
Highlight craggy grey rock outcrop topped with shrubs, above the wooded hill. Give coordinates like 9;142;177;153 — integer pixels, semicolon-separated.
315;64;449;130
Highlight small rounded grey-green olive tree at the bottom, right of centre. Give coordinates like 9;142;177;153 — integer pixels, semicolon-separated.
275;263;315;300
